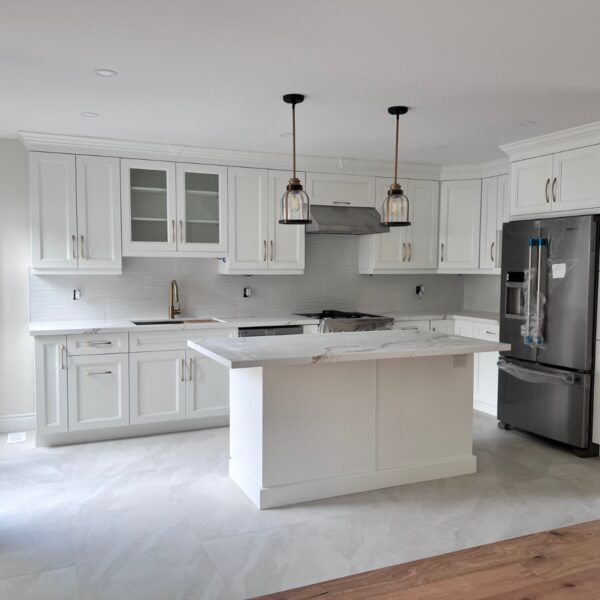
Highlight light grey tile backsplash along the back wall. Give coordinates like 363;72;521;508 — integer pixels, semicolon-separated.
30;235;463;321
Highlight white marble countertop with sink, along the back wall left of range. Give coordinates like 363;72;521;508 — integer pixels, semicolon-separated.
29;315;319;335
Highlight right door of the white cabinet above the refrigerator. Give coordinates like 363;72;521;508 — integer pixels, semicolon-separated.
551;146;600;211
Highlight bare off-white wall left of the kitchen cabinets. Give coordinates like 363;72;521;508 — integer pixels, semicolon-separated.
0;139;34;420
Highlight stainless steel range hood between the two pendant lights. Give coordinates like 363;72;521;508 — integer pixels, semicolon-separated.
306;204;390;235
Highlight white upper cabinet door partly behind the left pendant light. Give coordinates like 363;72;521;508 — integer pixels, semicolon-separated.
268;171;306;271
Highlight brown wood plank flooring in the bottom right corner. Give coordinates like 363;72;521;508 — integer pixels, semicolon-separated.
254;520;600;600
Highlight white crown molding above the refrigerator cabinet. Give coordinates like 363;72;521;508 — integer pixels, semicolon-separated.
500;121;600;161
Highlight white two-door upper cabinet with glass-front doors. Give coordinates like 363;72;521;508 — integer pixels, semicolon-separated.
121;159;227;257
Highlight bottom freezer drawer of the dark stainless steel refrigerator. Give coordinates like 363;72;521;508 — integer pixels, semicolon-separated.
498;359;592;448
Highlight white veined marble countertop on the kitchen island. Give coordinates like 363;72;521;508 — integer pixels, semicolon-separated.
188;331;510;369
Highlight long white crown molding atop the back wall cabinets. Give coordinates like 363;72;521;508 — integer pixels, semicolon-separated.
19;131;441;180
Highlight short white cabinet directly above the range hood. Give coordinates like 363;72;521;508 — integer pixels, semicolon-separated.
306;173;376;208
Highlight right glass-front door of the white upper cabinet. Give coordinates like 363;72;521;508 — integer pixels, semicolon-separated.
177;163;227;254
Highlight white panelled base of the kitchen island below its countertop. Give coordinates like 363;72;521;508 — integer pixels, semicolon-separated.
229;355;476;508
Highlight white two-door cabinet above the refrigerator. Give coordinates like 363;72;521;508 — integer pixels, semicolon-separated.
510;146;600;216
